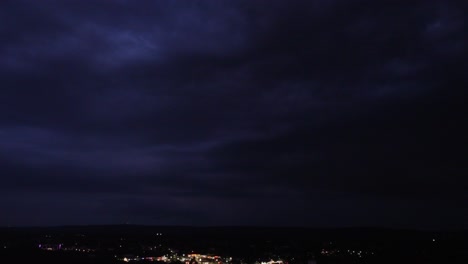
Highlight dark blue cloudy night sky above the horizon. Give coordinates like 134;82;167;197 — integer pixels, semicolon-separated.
0;0;468;229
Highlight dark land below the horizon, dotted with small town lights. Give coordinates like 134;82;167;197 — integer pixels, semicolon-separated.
0;225;468;264
